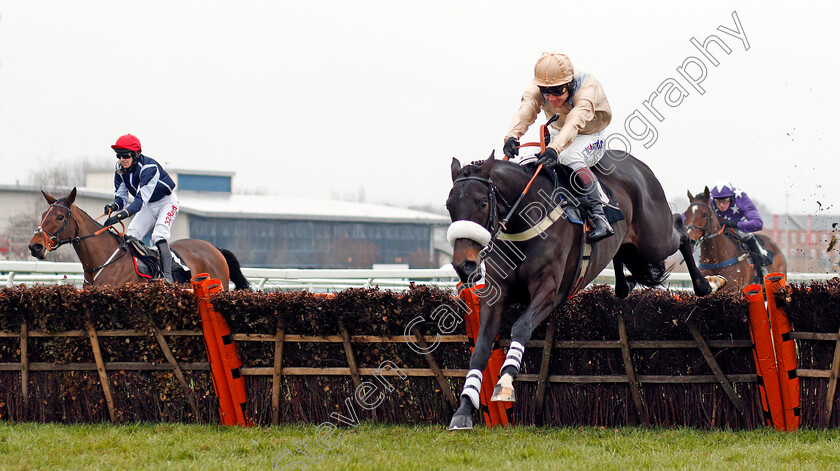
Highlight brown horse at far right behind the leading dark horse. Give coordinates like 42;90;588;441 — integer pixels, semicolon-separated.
683;187;787;289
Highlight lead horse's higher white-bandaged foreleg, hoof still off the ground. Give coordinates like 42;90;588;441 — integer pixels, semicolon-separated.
490;282;556;402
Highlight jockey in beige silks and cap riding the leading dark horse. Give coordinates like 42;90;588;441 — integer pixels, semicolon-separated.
504;52;613;242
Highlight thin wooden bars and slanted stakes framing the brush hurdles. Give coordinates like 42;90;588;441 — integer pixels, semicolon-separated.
0;313;840;426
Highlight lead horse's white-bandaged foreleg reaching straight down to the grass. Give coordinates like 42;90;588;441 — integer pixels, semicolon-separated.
449;302;503;430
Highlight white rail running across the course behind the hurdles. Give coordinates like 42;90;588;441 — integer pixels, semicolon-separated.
0;261;838;292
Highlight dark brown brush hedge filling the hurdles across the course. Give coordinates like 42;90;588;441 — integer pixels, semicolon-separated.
0;278;840;429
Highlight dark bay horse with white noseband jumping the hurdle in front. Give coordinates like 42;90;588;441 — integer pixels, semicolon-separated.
446;151;716;430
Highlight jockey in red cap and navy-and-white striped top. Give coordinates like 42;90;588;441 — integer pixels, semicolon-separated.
105;134;180;283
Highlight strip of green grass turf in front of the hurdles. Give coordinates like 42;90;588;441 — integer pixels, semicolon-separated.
0;423;840;471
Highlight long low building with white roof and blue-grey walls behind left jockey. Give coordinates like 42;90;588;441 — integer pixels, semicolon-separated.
0;169;451;268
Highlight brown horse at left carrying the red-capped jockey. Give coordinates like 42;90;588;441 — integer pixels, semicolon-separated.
29;188;249;289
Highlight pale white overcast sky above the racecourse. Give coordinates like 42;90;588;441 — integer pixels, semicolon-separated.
0;0;840;219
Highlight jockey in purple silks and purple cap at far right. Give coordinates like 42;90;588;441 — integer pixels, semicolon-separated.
711;181;768;278
